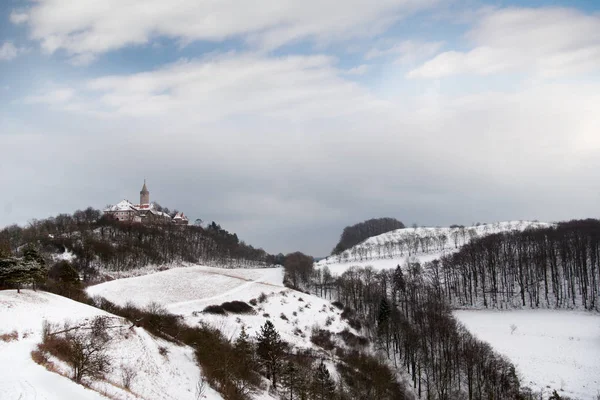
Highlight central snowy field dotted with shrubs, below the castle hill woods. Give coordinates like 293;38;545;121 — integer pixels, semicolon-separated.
87;266;358;354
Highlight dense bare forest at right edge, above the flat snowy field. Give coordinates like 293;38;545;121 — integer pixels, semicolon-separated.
434;219;600;310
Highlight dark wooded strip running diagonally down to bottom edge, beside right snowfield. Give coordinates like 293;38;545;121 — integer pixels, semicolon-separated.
317;263;528;400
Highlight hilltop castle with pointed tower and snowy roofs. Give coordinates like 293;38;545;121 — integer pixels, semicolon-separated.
104;179;189;225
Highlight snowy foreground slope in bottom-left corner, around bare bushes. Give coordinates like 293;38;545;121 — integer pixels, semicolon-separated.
0;290;221;400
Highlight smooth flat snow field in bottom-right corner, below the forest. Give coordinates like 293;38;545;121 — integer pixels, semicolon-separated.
454;310;600;400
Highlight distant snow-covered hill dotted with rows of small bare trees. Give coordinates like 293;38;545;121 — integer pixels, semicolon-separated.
315;221;552;275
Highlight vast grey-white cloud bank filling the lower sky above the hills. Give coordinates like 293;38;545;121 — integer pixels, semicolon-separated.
10;53;600;254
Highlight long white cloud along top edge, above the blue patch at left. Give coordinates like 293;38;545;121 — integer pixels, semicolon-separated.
11;0;438;59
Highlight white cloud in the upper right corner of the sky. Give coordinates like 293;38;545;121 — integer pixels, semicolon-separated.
407;8;600;79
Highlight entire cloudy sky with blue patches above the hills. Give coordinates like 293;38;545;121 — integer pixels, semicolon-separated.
0;0;600;256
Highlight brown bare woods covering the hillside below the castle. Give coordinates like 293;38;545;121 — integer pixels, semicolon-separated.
0;208;275;279
